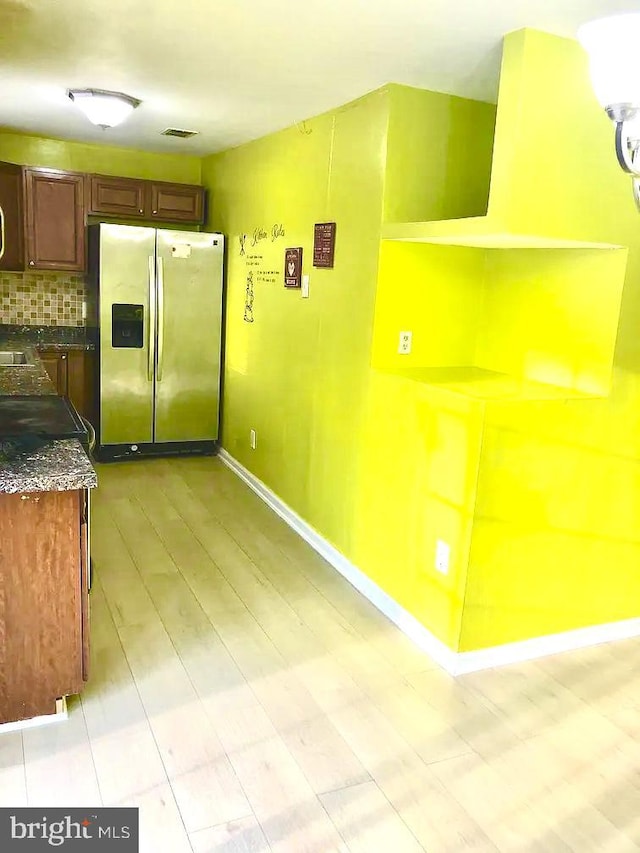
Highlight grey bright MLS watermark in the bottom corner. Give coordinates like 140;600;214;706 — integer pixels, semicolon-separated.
0;808;139;853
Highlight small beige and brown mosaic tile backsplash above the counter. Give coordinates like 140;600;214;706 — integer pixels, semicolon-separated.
0;272;87;326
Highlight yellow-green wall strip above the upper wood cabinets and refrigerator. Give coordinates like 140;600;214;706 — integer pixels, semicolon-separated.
0;128;201;184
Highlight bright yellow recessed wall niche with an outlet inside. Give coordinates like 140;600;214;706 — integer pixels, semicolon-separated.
372;240;627;400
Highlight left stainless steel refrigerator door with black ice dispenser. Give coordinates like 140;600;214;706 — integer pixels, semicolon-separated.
98;225;156;444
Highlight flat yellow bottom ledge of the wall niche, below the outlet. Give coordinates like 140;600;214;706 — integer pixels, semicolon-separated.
378;367;604;403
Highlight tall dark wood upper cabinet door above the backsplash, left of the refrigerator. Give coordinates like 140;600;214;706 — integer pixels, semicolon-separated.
25;169;86;271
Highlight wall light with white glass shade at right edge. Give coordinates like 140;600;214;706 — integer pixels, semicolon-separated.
578;12;640;208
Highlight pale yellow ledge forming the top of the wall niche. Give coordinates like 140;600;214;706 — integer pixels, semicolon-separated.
382;216;621;249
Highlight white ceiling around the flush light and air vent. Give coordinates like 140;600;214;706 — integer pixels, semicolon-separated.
0;0;640;154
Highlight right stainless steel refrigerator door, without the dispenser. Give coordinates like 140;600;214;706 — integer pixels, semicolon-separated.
155;230;224;442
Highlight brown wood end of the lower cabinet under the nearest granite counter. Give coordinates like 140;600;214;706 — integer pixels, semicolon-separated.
0;489;89;723
